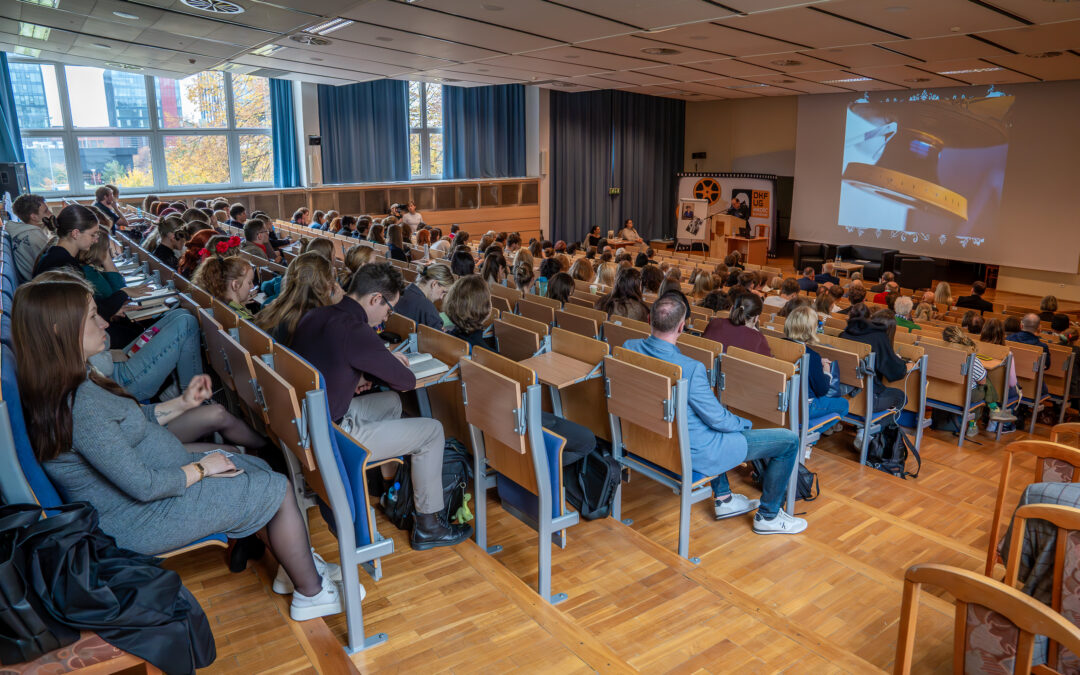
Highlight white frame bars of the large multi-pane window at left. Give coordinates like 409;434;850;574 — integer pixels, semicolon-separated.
10;58;273;199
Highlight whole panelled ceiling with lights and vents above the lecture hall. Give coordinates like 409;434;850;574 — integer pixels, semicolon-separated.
0;0;1080;100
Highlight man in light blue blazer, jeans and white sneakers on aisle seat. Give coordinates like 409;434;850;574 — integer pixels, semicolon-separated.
623;292;807;535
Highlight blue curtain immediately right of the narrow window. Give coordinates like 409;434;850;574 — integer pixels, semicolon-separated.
443;84;525;178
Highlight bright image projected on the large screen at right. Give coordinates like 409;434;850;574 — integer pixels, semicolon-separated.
839;86;1014;234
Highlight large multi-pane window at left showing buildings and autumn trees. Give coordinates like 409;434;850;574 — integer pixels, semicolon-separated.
9;58;273;197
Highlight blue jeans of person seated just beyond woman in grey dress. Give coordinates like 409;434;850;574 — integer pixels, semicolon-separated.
112;309;202;401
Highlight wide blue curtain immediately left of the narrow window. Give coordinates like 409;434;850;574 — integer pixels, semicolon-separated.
319;80;409;183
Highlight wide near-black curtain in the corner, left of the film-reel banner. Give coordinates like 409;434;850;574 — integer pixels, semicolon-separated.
550;90;686;243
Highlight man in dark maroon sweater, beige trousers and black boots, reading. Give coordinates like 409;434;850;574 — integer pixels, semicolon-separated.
293;264;470;550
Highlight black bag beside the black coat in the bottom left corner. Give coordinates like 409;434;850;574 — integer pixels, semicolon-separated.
0;504;79;665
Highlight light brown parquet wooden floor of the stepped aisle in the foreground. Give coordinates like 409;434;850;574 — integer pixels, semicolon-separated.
167;410;1062;674
